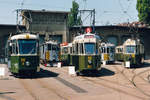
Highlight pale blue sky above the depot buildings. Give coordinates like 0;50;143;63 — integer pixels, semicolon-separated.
0;0;138;25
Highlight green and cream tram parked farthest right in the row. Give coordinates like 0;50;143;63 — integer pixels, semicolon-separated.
123;39;144;66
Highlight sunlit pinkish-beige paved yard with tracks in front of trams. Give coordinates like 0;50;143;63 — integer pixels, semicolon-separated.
0;61;150;100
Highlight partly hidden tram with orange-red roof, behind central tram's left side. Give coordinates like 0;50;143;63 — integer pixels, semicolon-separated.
60;42;72;65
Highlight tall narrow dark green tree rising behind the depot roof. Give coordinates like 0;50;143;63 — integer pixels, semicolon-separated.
68;0;82;27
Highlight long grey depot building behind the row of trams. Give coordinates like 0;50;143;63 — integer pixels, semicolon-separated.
0;10;150;63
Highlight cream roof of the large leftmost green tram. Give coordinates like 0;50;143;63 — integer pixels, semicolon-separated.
10;33;38;40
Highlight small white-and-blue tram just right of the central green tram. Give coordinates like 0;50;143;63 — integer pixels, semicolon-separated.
100;42;115;64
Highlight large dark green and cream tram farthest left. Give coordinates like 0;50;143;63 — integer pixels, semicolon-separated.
7;33;40;75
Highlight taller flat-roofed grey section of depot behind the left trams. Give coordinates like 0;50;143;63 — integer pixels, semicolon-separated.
21;10;69;43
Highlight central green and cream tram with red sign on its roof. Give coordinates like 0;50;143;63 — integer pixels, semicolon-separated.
71;33;101;73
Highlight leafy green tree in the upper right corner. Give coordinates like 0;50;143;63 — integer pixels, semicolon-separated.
136;0;150;25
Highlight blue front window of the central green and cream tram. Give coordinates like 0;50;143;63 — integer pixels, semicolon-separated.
84;43;95;54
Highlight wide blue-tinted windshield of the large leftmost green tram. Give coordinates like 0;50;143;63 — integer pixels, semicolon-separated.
18;40;37;54
